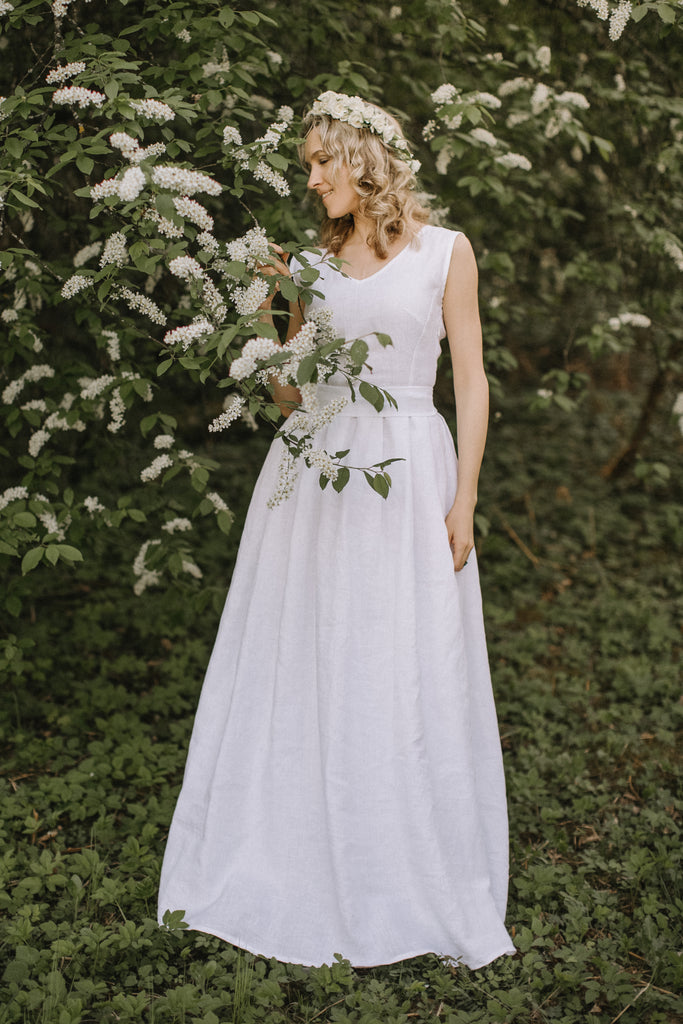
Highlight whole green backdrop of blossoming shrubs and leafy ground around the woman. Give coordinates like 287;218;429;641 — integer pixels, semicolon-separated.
0;0;683;1024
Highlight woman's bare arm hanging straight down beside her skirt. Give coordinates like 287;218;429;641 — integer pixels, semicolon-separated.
443;234;488;571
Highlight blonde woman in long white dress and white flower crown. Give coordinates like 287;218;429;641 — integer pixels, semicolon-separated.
159;93;514;968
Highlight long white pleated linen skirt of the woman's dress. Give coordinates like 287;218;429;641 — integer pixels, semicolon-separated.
159;389;514;968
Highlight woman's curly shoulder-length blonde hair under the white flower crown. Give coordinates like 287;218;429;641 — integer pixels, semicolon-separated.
300;104;429;259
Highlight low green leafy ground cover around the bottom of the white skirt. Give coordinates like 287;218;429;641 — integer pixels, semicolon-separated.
0;387;683;1024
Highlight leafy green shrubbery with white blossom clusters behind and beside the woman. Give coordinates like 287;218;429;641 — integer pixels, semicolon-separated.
0;0;683;613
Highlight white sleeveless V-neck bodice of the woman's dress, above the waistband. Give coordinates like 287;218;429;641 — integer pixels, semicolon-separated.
292;224;459;389
